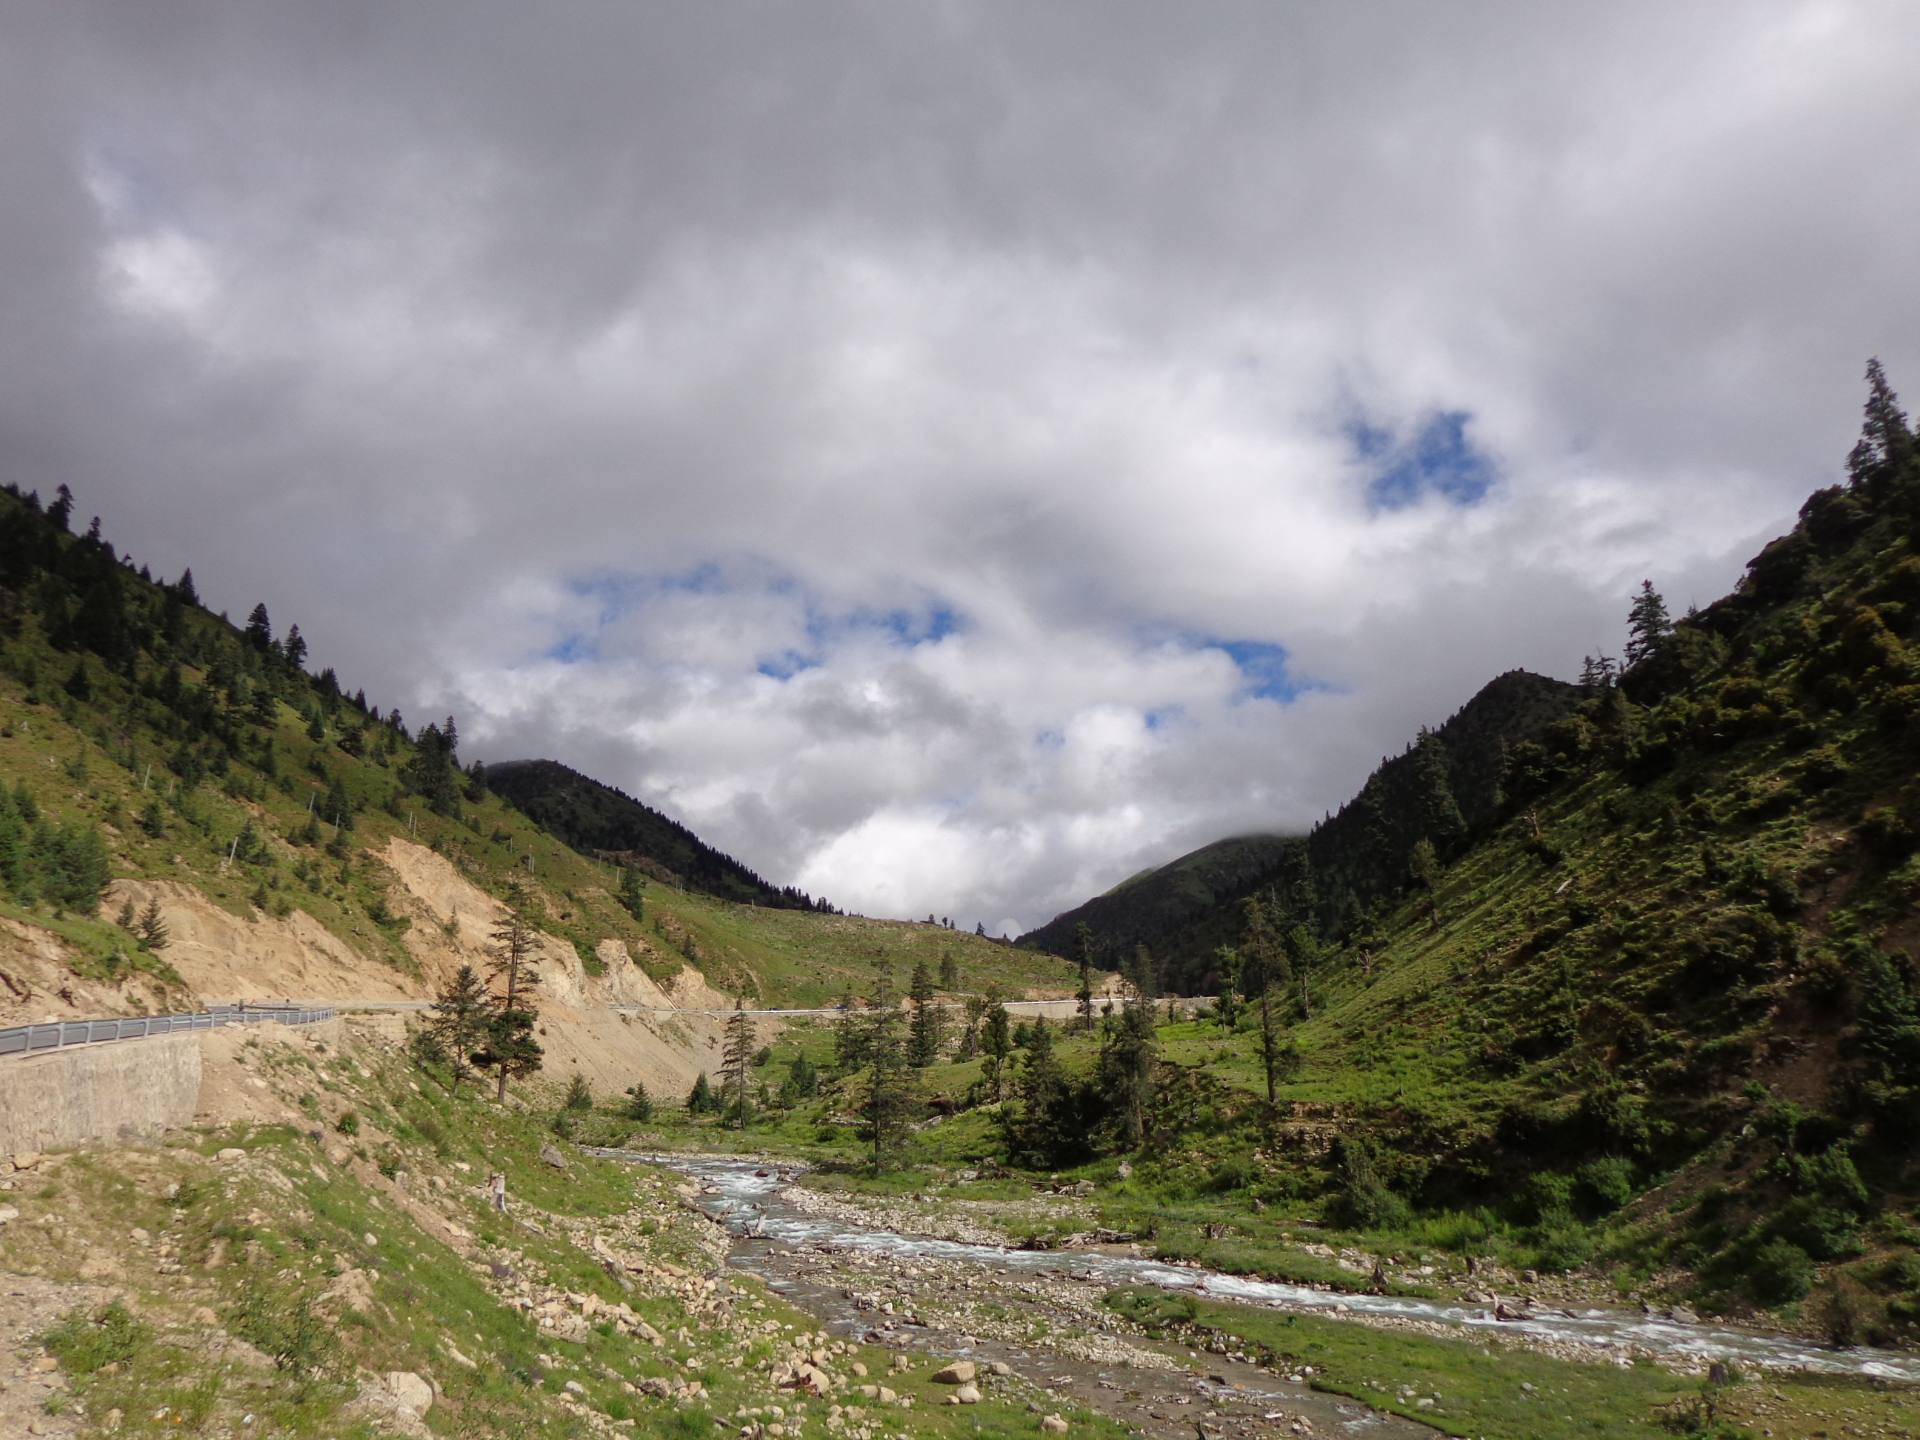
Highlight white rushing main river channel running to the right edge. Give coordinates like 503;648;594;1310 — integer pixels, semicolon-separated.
603;1152;1920;1384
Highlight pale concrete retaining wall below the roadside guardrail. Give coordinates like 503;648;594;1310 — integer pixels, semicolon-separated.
0;1035;200;1154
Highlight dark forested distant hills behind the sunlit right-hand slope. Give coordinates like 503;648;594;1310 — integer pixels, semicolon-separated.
1018;670;1580;993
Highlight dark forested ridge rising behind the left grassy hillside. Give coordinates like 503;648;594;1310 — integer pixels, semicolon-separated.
484;760;833;912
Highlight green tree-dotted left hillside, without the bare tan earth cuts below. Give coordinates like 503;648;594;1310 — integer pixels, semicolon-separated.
0;490;1068;1004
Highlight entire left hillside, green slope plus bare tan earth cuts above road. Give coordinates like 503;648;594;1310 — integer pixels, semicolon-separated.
0;488;1066;1052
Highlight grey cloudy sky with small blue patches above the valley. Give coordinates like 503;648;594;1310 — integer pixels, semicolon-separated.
0;0;1920;931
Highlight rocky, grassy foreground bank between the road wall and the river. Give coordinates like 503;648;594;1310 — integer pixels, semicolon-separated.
0;1023;1121;1440
